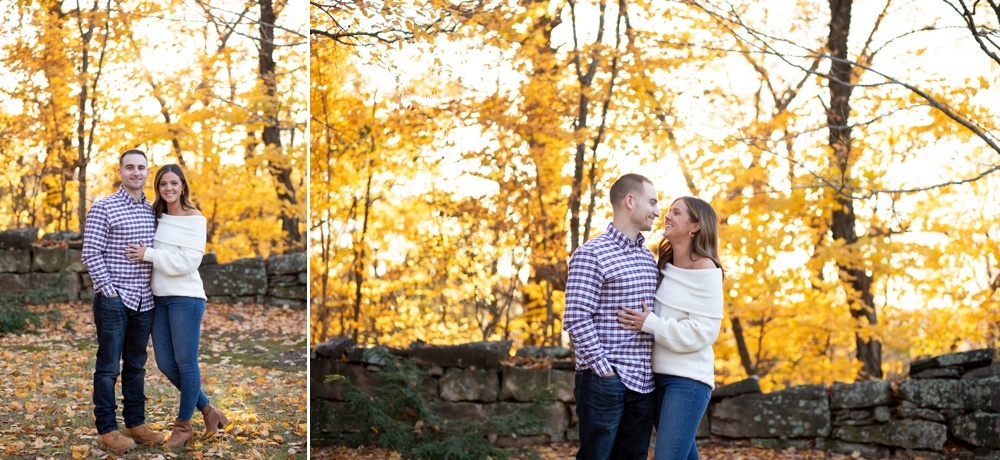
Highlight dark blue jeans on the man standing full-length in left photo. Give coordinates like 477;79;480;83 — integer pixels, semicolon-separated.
94;292;153;434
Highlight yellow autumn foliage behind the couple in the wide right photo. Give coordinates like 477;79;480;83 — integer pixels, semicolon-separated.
311;1;1000;390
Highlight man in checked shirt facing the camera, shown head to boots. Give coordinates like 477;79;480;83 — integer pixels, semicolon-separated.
82;149;163;452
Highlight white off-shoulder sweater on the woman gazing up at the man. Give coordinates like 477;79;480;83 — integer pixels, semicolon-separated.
642;264;722;389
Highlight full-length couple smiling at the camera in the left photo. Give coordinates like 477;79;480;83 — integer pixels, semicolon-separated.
82;149;228;452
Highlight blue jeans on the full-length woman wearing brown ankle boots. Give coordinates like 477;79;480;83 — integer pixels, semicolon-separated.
153;296;208;420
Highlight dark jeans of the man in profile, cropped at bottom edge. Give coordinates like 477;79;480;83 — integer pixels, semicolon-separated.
573;370;656;460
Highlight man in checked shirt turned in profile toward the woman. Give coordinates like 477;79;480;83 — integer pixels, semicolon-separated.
563;174;660;460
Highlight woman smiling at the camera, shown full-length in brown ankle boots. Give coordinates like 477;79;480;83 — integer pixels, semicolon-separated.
126;164;229;448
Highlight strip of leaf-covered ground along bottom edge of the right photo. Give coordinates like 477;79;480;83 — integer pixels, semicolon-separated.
310;443;861;460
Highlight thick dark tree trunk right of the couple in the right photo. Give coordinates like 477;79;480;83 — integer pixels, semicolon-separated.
827;0;882;380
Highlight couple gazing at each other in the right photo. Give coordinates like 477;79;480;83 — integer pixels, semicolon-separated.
563;174;723;460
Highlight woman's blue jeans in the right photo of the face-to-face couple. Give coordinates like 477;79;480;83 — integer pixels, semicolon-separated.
653;374;712;460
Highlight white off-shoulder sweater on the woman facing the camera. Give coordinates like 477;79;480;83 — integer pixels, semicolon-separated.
142;214;208;299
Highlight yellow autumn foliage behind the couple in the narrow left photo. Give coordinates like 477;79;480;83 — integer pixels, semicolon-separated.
0;0;308;262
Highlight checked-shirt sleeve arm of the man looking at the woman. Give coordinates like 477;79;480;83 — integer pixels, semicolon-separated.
563;248;614;376
